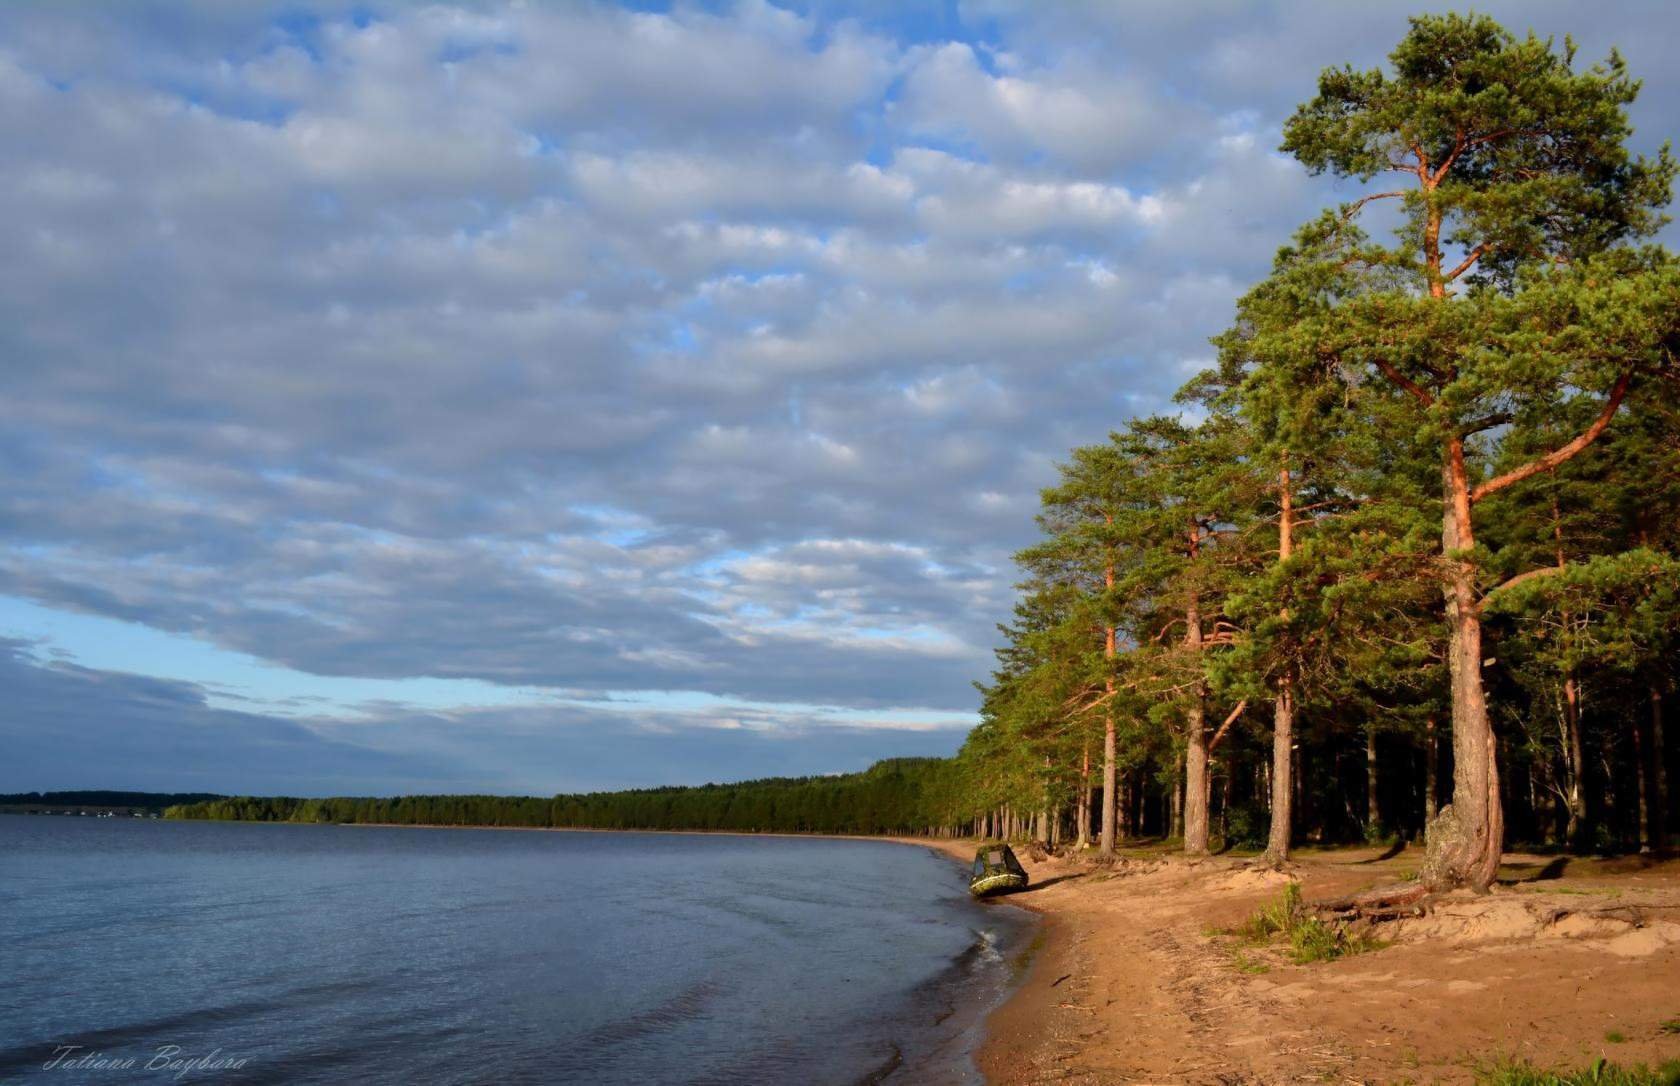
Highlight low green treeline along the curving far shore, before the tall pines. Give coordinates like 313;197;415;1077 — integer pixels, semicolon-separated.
165;758;956;834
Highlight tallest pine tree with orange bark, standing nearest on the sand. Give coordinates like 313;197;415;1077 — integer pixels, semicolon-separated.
1263;15;1680;888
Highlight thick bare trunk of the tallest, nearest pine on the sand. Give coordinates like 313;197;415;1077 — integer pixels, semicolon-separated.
1420;437;1505;891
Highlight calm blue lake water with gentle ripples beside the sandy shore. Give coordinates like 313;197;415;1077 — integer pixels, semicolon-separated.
0;815;1028;1083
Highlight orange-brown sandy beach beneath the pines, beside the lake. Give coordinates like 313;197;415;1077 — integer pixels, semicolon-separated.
934;842;1680;1086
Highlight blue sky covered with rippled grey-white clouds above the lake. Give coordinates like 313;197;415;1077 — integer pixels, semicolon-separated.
0;0;1680;795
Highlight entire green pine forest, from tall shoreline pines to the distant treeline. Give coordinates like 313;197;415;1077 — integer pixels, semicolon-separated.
170;15;1680;888
